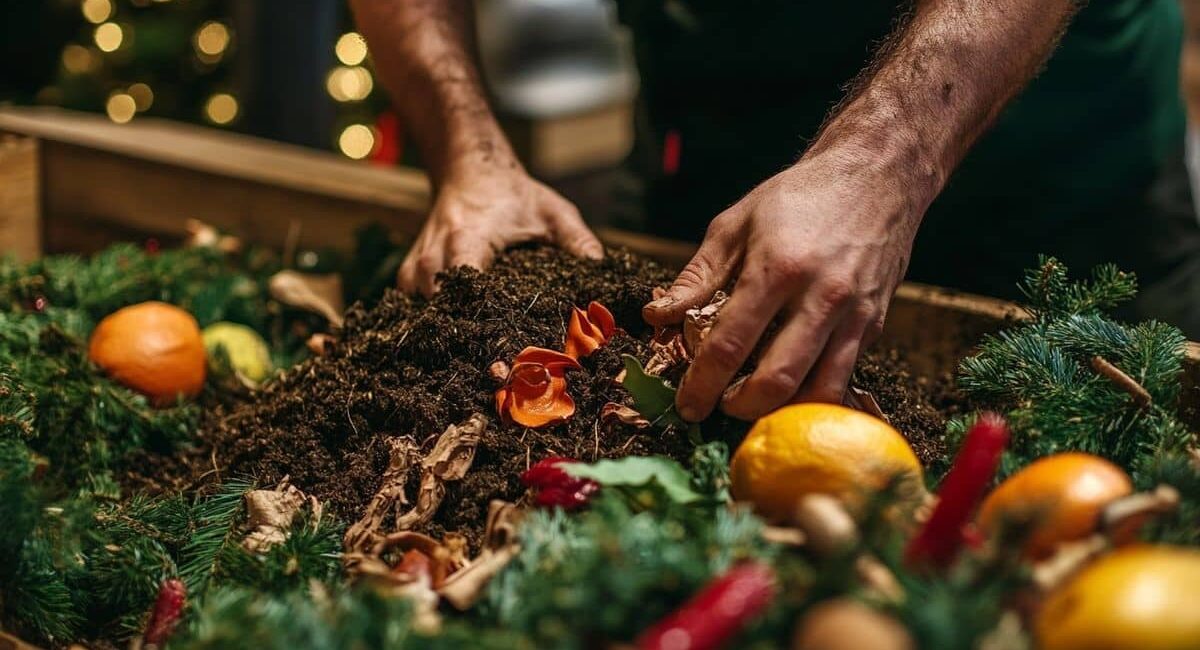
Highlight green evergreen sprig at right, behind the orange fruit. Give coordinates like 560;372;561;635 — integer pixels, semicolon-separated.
948;258;1190;475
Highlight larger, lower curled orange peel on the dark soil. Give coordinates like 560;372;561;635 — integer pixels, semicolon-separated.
496;347;580;428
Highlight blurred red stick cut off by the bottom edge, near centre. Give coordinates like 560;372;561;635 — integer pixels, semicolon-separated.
637;562;775;650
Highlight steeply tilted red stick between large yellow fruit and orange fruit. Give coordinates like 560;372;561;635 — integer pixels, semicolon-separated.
905;413;1008;566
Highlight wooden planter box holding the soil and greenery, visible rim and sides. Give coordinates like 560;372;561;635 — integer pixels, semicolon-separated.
0;108;1200;427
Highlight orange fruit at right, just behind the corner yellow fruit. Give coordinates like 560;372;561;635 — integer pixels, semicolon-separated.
979;452;1133;559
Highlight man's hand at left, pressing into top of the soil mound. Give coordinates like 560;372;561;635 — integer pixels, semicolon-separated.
398;164;604;296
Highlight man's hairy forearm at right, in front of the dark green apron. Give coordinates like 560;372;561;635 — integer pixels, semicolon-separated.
805;0;1075;218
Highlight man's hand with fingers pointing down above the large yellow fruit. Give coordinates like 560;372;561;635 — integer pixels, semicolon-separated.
644;150;920;421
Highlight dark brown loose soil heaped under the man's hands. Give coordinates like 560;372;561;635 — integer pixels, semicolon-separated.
143;246;948;547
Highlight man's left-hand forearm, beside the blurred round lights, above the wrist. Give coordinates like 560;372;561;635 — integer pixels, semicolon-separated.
350;0;517;185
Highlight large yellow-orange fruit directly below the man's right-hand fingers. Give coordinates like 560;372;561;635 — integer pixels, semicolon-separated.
730;403;924;520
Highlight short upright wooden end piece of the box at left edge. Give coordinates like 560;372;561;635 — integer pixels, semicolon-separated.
0;136;42;260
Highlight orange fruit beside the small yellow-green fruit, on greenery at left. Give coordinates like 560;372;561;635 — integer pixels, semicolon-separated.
88;301;205;407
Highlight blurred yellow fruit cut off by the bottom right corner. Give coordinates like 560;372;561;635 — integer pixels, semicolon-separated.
1033;544;1200;650
